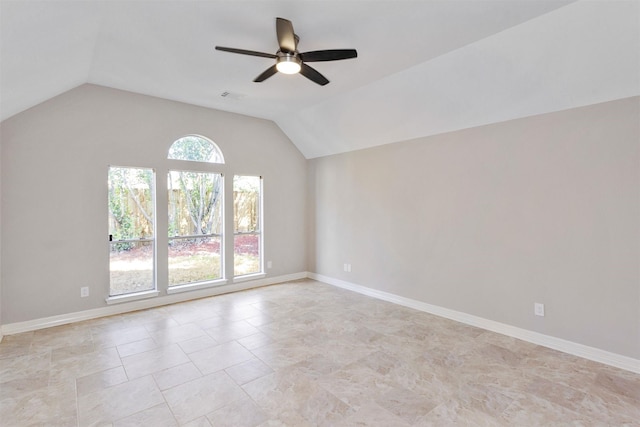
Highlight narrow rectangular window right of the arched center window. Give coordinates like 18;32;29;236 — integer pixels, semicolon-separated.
233;176;263;276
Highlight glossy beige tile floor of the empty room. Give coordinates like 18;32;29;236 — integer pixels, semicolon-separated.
0;280;640;427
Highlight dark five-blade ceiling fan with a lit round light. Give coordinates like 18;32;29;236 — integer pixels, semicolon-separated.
216;18;358;86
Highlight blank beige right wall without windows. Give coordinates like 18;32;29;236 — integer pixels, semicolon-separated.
308;98;640;358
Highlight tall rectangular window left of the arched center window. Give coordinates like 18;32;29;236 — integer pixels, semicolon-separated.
108;167;156;296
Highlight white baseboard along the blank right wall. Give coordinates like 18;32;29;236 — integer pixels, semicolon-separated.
308;273;640;374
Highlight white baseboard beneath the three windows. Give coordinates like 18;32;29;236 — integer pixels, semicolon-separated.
0;272;308;336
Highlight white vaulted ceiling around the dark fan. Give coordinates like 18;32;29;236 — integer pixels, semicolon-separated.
0;0;640;158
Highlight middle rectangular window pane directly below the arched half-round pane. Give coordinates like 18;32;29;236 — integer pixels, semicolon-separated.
167;171;224;287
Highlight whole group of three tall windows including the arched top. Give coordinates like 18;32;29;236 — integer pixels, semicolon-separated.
107;135;264;304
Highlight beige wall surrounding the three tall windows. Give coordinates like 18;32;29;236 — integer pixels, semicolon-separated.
0;85;307;324
